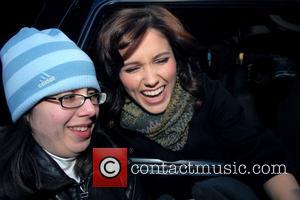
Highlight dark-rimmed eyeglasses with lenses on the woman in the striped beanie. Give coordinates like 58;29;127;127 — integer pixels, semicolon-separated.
45;92;106;108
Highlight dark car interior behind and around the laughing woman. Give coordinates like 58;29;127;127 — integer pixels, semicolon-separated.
0;1;300;198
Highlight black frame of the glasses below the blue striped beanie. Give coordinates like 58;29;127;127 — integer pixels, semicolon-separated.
45;92;106;108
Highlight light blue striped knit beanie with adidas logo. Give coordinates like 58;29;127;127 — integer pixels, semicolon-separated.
0;27;100;122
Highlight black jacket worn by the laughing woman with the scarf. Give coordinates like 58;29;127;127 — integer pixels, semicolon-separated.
110;75;292;199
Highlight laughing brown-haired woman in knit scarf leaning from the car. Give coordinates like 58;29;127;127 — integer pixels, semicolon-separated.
97;6;300;200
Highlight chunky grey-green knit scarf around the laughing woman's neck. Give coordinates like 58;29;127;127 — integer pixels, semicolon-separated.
120;83;195;151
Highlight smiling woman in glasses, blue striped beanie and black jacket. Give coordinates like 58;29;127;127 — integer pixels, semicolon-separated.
0;28;140;200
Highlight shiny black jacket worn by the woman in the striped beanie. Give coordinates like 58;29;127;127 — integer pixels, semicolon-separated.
0;145;145;200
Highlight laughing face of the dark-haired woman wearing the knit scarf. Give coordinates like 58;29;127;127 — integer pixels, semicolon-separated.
119;29;176;114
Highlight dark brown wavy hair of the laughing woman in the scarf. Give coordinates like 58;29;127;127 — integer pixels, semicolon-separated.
96;5;205;126
